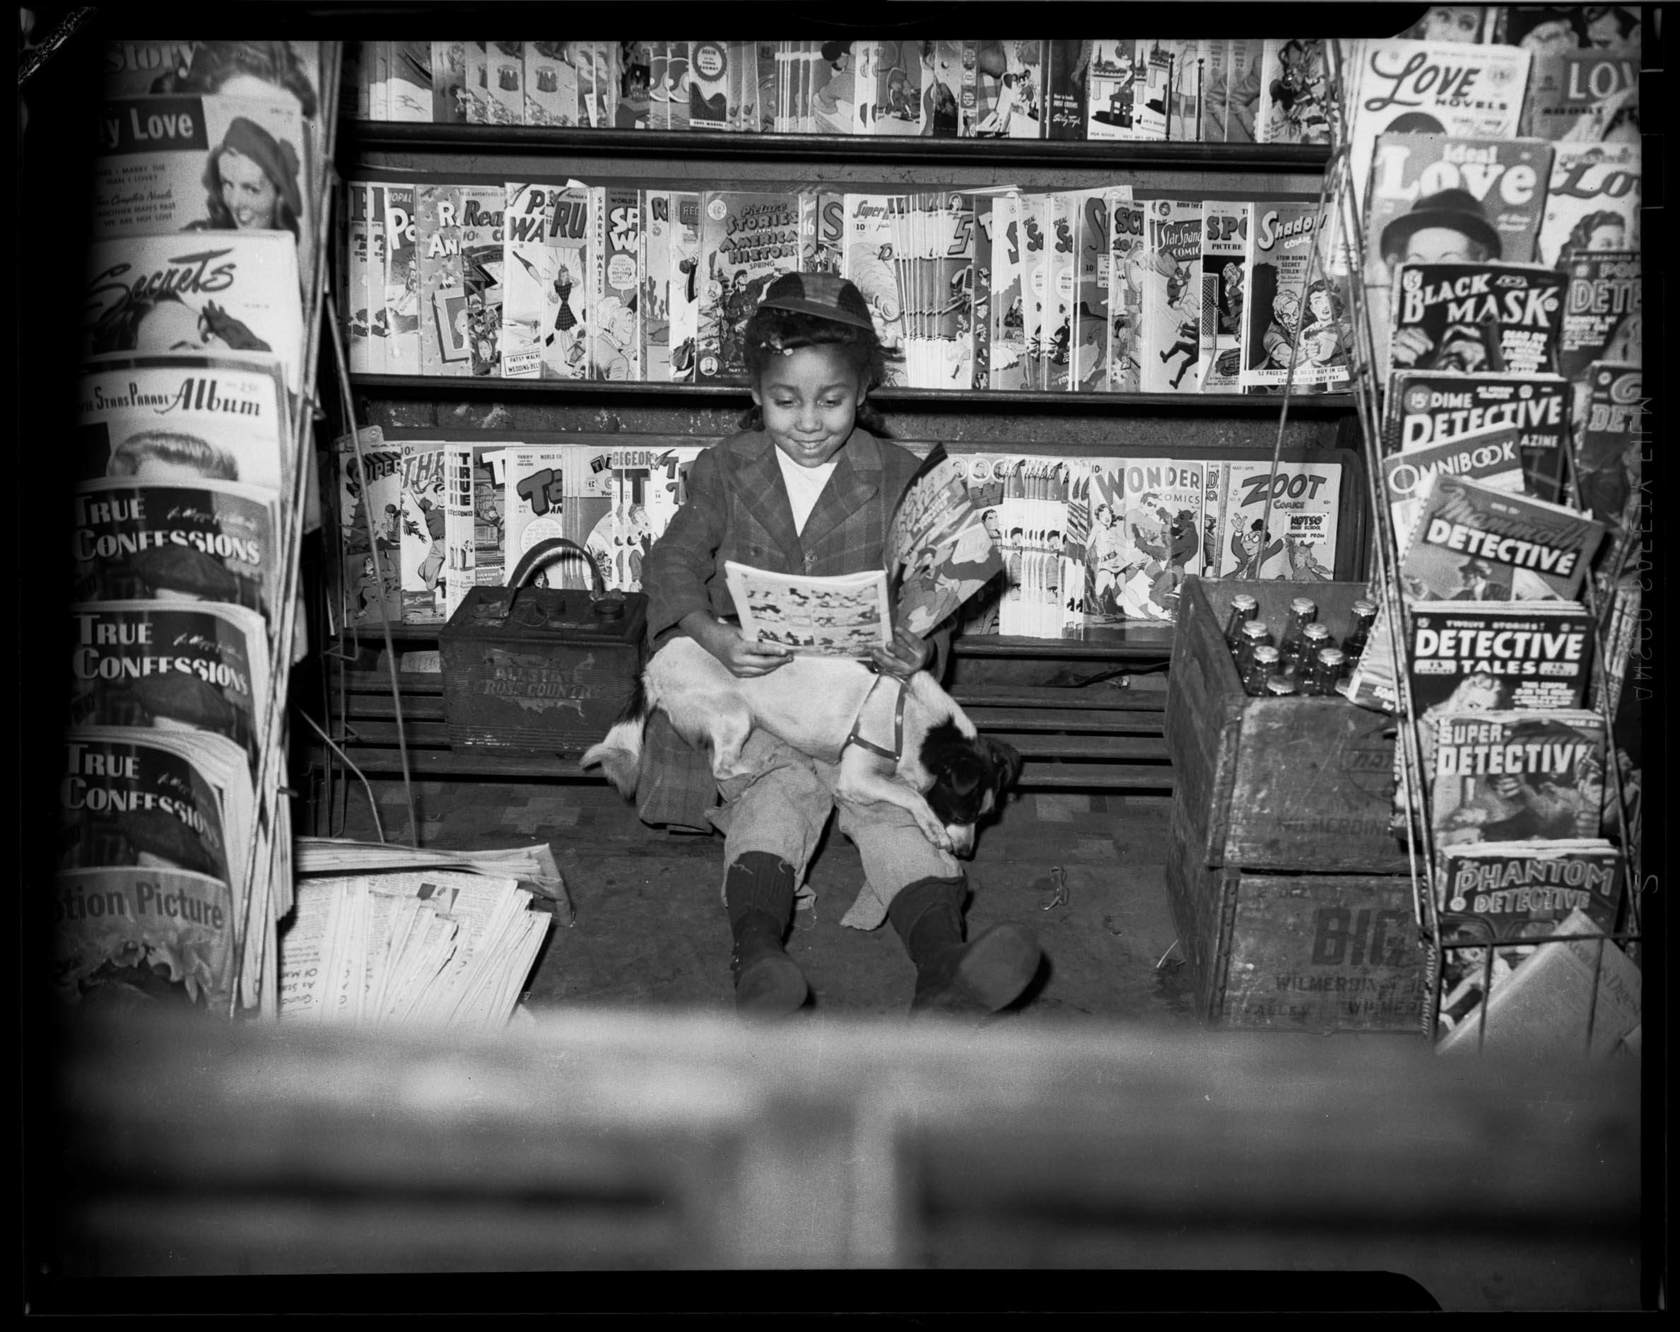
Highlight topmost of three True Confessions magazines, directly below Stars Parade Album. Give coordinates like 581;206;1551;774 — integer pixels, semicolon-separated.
71;477;280;618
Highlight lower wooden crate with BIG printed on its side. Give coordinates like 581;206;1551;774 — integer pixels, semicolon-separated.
1166;806;1428;1036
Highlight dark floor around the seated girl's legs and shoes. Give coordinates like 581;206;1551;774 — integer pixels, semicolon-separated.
324;781;1196;1028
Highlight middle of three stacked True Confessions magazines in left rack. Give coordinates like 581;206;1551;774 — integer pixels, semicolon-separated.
69;601;269;779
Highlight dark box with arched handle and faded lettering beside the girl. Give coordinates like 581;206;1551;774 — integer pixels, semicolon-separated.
438;541;647;754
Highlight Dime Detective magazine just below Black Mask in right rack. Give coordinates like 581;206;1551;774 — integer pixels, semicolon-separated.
1383;371;1569;507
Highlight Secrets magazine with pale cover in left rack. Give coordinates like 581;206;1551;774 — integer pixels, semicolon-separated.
82;232;304;393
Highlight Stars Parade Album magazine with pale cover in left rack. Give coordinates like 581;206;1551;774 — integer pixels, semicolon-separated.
77;351;297;506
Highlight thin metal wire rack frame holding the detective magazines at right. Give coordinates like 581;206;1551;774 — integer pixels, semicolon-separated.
1320;42;1643;1050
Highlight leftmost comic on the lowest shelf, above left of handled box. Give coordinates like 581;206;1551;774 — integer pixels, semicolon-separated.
338;425;403;628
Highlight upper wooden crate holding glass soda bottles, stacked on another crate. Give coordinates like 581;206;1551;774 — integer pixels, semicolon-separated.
1164;578;1408;875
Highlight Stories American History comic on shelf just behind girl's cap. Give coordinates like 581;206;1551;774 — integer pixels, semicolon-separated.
694;190;799;383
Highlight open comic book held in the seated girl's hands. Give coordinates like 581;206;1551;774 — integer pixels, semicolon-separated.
724;447;1003;657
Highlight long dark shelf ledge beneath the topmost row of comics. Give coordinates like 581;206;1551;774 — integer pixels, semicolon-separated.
338;119;1329;171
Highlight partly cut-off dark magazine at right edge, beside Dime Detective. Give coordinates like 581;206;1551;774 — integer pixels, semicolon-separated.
1574;361;1648;585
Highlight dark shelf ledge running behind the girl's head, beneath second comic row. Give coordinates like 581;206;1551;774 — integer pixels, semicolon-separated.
349;373;1352;417
